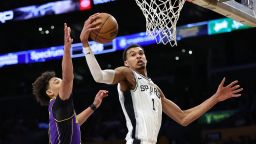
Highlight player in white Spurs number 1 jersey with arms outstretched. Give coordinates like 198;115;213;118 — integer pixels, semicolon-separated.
80;14;243;144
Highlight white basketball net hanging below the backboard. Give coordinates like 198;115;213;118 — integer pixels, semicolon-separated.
135;0;186;46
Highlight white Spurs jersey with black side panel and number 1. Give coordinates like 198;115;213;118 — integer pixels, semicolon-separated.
118;71;162;144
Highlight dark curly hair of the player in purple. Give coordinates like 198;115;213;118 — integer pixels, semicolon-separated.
32;71;56;106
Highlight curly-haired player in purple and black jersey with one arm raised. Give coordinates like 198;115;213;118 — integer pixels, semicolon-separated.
33;23;108;144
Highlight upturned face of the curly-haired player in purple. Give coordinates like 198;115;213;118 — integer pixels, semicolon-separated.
46;77;62;98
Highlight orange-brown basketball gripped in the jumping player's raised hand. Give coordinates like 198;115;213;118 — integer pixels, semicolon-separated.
90;13;118;44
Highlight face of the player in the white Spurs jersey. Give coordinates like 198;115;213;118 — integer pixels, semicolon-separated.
125;47;147;69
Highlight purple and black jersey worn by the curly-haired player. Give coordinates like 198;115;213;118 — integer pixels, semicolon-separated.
48;96;81;144
